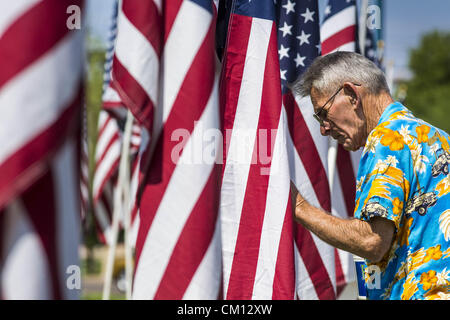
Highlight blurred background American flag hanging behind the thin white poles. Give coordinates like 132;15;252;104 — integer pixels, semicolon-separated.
93;1;141;246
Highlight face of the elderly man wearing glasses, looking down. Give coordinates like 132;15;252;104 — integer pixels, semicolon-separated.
311;83;366;151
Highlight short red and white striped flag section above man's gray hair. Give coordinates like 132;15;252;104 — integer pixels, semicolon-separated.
320;6;356;55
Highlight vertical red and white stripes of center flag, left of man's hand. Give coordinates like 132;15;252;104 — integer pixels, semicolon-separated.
220;15;295;299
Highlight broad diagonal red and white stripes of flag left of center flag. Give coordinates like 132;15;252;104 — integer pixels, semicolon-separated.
113;0;221;299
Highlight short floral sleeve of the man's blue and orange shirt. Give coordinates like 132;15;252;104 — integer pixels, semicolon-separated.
354;137;411;231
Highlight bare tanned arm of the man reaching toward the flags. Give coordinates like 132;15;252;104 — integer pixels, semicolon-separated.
291;184;395;262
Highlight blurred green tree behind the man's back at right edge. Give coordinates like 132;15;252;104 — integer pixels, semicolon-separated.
405;31;450;132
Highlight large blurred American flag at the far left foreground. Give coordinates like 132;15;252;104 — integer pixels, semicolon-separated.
0;0;83;299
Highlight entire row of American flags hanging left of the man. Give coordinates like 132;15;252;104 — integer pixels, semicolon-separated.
0;0;384;299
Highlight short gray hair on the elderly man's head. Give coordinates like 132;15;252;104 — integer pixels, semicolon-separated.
290;51;389;96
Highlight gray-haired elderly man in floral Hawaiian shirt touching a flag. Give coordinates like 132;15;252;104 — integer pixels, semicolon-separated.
291;52;450;299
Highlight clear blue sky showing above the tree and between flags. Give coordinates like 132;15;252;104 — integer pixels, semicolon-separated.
86;0;450;78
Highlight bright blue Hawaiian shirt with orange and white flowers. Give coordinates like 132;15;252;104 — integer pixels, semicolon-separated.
355;102;450;300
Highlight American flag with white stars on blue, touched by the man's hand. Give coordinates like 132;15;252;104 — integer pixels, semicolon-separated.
221;0;341;299
